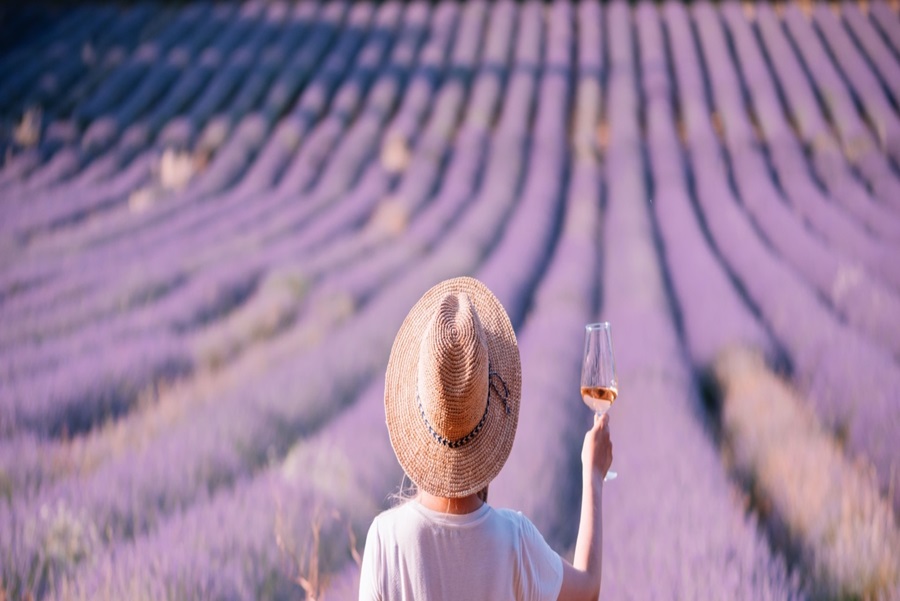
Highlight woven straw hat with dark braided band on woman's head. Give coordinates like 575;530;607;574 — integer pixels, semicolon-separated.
384;277;522;498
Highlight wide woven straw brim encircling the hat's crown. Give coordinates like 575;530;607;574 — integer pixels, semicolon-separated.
384;277;522;498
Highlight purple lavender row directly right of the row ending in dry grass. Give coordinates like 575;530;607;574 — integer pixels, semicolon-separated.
665;4;900;506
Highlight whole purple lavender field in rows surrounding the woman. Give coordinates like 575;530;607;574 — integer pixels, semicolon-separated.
0;0;900;600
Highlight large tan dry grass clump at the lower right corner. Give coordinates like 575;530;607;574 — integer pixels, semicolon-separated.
714;350;900;599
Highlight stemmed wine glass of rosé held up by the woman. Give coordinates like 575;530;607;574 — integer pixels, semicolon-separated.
581;321;619;480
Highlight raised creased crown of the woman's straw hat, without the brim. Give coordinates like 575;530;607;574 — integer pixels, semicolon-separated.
416;293;489;440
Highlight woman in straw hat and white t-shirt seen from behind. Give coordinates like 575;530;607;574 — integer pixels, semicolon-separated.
359;277;612;601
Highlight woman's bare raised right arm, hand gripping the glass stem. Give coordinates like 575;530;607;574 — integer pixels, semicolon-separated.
559;415;612;601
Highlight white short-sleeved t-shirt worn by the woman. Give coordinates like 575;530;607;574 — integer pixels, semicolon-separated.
359;501;563;601
